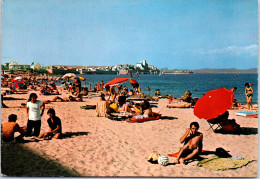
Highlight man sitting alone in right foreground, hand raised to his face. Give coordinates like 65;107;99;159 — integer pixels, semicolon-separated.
175;122;203;164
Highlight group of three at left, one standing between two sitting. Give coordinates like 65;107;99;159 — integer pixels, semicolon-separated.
1;93;62;142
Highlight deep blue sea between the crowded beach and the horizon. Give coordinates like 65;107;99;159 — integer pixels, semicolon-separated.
65;74;258;104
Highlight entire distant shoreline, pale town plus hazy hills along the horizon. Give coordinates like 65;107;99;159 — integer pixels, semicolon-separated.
1;60;258;75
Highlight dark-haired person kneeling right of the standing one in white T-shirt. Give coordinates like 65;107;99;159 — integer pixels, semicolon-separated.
38;108;62;139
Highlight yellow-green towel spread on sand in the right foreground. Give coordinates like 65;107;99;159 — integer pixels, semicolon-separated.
197;155;253;171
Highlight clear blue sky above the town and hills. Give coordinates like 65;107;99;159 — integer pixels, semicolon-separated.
1;0;258;69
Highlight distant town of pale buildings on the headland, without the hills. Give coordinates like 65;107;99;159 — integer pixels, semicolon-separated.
1;60;160;75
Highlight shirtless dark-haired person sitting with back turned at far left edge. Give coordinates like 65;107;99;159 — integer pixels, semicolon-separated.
1;114;26;142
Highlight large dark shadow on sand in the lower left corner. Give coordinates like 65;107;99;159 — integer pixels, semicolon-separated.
1;144;80;177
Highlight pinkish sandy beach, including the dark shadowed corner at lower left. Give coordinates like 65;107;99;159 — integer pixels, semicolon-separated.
1;89;258;177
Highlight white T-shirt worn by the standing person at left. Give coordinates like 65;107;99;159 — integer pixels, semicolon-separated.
27;100;43;121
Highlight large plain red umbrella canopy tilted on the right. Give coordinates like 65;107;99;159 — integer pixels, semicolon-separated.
193;88;234;119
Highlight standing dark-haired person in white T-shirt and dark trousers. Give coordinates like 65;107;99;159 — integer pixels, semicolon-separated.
26;93;45;136
